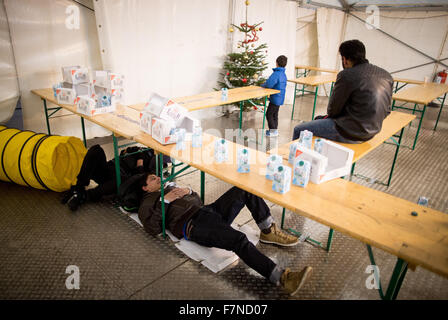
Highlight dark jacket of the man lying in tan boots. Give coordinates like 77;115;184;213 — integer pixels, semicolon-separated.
138;187;203;238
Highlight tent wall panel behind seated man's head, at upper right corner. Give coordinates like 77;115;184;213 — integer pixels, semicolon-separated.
345;11;448;81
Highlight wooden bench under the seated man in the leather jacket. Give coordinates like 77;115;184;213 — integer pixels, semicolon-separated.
269;111;415;187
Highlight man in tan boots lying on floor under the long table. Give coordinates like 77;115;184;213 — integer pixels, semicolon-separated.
138;174;312;295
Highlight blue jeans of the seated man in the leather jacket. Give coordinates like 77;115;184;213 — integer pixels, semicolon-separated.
292;118;362;143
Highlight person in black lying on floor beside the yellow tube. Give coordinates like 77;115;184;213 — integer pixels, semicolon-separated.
61;144;170;211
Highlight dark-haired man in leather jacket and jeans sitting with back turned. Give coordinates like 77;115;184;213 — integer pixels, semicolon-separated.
292;40;393;143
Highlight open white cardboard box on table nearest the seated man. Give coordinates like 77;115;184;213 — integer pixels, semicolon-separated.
295;140;354;184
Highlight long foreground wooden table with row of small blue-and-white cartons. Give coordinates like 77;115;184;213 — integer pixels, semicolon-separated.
134;129;448;299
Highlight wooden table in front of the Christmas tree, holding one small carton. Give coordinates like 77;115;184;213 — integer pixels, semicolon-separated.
129;86;280;137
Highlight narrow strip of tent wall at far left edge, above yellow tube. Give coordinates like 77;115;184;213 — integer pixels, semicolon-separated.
0;1;19;123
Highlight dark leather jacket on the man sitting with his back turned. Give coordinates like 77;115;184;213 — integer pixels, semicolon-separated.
327;62;393;141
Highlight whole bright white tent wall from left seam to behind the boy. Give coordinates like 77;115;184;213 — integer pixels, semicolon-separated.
94;0;296;118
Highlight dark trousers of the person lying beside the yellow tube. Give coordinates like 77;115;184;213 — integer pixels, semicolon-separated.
76;145;124;201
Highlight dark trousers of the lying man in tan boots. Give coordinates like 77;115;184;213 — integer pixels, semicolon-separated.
189;187;276;279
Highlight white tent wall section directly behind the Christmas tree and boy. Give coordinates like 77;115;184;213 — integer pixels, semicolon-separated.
233;0;297;104
